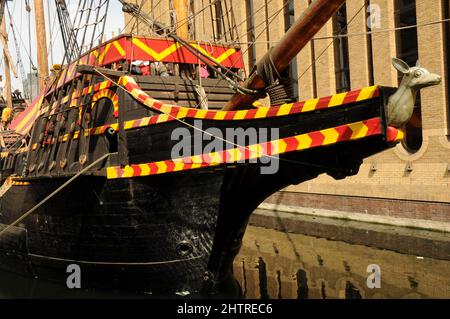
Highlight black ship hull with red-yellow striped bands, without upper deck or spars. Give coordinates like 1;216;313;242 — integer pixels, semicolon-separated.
0;71;398;297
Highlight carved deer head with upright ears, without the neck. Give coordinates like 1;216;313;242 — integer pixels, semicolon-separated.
392;58;442;90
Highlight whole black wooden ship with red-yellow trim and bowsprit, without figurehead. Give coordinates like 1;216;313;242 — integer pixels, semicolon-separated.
0;0;403;296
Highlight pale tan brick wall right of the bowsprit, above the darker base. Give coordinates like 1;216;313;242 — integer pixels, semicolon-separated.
286;0;450;206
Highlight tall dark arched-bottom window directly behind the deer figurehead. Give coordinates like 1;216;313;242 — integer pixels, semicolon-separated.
395;0;423;153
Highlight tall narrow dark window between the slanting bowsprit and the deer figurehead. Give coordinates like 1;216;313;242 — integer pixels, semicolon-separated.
333;4;351;93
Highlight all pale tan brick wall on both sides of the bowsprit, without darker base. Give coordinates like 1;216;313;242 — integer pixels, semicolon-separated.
126;0;450;210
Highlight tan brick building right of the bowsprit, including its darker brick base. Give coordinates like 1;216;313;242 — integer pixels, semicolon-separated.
278;0;450;228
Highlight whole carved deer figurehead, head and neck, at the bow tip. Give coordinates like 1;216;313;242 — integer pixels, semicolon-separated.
388;58;441;128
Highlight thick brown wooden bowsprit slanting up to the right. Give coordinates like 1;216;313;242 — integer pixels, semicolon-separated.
223;0;345;111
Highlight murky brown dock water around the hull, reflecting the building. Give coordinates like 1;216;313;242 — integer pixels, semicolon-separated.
0;226;450;299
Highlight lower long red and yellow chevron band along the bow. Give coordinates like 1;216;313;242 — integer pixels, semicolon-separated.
107;118;403;179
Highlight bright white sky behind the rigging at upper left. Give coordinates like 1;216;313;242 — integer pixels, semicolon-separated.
0;0;124;91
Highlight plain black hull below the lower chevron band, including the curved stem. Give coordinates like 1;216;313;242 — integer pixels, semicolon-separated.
0;132;392;297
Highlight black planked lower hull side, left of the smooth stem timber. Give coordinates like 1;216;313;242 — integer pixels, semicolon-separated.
0;173;230;293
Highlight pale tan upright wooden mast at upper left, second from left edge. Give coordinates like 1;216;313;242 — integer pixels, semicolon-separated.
34;0;48;90
